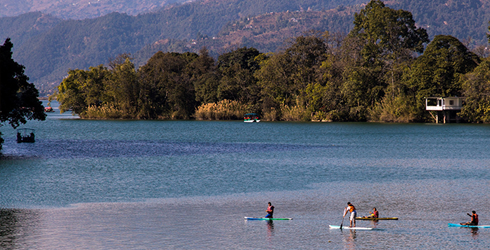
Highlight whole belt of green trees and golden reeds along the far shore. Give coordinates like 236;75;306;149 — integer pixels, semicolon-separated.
53;0;490;122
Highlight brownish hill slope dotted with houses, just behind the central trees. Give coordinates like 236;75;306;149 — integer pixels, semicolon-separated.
133;6;361;66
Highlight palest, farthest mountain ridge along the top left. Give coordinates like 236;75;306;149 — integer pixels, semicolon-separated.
0;0;191;20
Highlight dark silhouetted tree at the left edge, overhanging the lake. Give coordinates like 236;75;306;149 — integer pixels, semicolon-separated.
0;38;46;149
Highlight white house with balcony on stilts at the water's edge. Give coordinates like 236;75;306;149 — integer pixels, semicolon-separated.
425;97;464;123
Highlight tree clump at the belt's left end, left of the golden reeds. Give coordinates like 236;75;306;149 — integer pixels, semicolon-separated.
53;50;214;119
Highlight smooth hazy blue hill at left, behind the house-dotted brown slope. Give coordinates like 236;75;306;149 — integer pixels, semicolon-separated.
0;0;367;94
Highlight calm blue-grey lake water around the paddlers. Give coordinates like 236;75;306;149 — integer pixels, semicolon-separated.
0;101;490;249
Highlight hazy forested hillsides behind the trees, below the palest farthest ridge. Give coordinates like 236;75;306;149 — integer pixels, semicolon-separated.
0;0;490;95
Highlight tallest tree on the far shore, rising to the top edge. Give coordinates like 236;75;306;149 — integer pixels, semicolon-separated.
344;0;429;120
